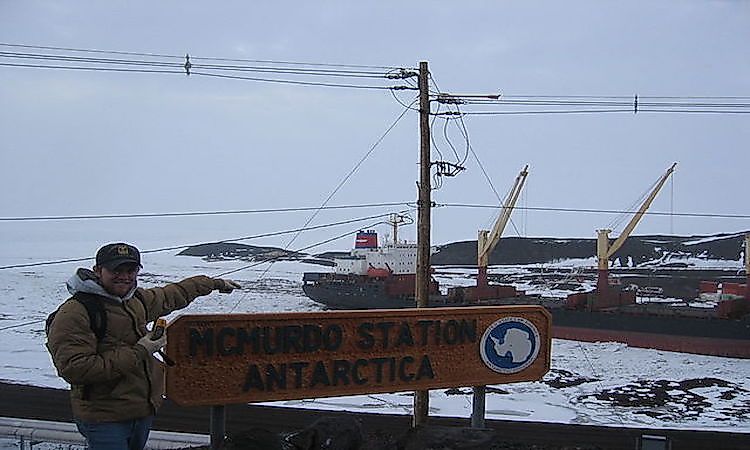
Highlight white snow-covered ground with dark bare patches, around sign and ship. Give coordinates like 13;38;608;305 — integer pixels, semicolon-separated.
0;241;750;433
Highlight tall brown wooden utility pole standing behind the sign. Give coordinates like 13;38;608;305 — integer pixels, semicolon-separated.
412;61;432;427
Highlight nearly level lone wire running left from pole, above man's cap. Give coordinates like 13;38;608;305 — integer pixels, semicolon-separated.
0;202;411;222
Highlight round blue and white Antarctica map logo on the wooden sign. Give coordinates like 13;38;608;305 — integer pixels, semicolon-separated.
479;317;540;374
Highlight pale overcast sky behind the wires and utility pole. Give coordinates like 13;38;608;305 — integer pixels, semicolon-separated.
0;0;750;253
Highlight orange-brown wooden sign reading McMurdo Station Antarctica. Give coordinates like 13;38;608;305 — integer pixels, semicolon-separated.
166;306;551;406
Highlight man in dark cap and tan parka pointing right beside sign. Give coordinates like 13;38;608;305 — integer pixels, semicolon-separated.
47;243;240;450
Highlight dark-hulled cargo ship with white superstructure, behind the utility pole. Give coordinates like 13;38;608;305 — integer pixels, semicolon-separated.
302;230;750;358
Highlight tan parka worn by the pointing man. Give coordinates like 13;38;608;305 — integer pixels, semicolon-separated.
47;275;221;422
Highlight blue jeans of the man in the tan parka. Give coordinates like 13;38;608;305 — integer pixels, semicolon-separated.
76;416;154;450
